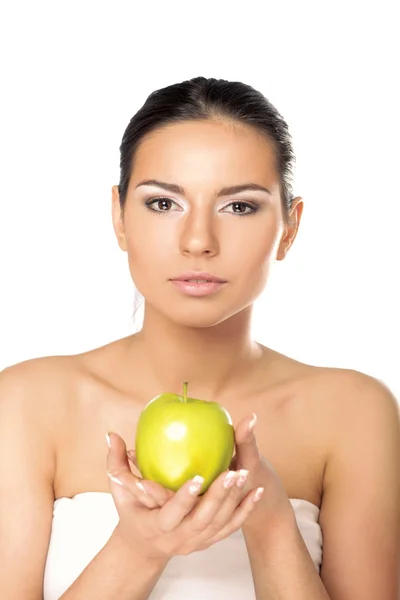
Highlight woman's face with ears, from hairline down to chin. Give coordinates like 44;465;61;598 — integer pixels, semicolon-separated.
113;121;301;327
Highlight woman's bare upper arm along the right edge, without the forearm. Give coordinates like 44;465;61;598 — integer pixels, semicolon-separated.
320;372;400;600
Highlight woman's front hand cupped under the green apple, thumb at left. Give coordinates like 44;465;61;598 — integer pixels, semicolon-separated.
107;433;263;560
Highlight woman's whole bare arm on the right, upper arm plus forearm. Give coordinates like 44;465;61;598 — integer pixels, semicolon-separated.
242;371;400;600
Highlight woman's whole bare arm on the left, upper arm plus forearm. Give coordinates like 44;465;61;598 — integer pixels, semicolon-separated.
0;359;164;600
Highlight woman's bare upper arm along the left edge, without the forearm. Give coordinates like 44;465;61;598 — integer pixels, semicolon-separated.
0;363;54;600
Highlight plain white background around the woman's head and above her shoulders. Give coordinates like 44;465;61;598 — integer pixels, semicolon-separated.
0;0;400;398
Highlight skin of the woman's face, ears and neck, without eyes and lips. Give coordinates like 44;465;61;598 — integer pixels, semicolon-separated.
109;116;303;400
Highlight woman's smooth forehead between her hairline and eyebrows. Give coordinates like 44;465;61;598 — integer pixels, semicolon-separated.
132;120;278;186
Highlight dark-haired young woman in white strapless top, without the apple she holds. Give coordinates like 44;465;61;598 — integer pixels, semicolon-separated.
0;77;400;600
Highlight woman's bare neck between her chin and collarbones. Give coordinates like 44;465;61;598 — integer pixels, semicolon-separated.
132;305;262;400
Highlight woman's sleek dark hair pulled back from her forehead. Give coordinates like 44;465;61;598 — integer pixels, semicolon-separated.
118;77;295;220
